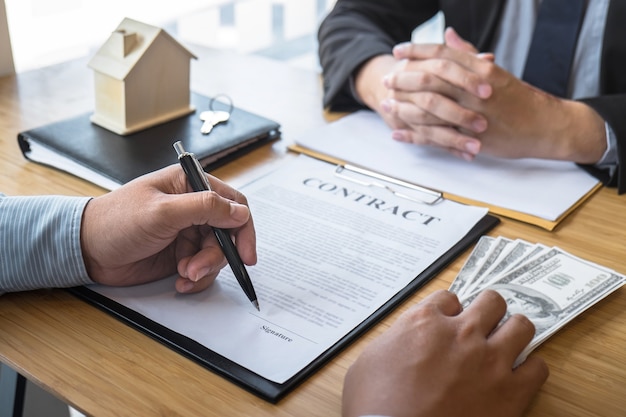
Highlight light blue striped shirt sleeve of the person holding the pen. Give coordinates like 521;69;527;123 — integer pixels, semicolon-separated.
0;194;93;294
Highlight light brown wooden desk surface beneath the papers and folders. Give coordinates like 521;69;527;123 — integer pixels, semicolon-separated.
0;49;626;417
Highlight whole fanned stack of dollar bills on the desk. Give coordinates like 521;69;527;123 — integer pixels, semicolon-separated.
450;236;626;366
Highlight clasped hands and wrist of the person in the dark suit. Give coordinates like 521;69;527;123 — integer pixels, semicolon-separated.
355;28;606;164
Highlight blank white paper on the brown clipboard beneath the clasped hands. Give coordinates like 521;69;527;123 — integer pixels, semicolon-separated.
296;110;598;221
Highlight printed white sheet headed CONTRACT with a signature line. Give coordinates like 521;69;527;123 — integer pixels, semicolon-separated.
78;155;497;400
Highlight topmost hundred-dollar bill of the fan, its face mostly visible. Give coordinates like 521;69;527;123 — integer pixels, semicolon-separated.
462;248;626;364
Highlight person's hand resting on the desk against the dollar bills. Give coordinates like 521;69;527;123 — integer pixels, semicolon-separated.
342;291;548;417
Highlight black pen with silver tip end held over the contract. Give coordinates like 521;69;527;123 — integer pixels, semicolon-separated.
174;141;261;311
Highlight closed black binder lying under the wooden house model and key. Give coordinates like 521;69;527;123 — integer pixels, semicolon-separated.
17;93;280;190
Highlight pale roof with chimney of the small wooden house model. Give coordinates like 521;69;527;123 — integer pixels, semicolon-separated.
88;18;196;80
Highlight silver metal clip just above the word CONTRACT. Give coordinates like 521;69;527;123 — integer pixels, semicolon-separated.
335;164;443;206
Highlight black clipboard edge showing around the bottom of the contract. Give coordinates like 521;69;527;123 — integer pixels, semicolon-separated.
68;214;500;403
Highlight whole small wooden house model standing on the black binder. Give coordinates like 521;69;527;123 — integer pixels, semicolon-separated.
88;18;196;135
